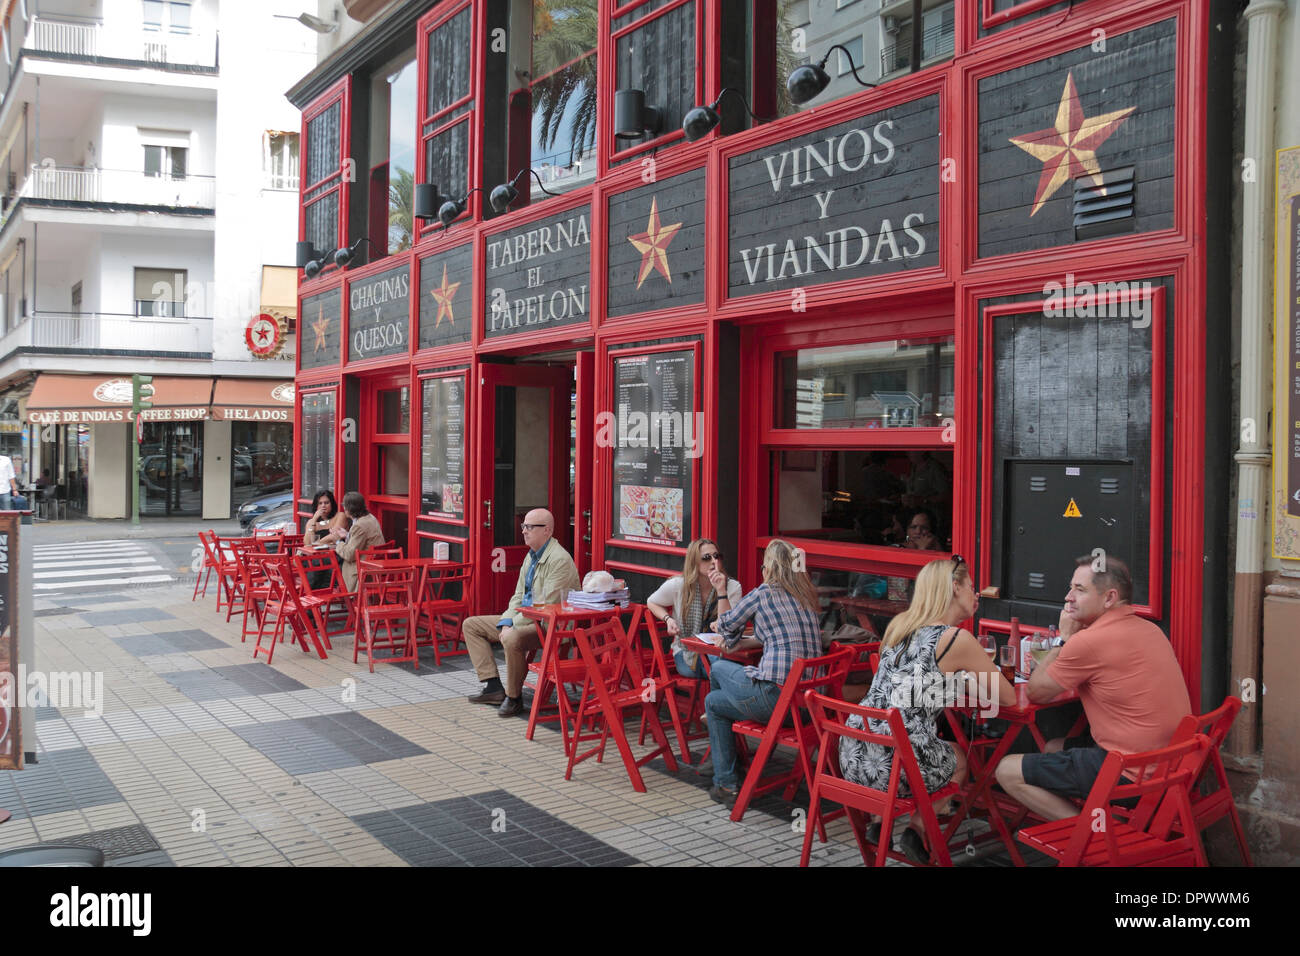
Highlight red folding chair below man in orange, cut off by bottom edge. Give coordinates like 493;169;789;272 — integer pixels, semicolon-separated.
1015;734;1210;866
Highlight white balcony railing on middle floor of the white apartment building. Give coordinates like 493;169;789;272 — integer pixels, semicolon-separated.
16;163;217;209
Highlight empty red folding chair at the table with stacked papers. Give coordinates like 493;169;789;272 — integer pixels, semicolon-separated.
572;619;677;793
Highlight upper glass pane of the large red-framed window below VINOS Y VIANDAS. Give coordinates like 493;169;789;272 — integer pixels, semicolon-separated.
774;336;956;429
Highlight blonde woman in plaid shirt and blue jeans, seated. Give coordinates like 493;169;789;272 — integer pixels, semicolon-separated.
705;538;822;806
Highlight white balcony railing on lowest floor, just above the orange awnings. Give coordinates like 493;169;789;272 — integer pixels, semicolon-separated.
0;312;212;359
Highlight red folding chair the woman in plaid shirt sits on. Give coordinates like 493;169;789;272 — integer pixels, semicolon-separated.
732;650;852;843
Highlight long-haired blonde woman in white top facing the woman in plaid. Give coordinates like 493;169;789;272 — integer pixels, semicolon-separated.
646;537;741;680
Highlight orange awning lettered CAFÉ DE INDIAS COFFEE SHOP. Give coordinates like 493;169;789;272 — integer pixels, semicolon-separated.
27;372;212;425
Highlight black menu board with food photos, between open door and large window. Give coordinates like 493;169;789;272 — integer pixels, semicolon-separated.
611;349;703;546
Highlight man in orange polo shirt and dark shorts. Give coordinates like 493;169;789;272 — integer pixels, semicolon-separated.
997;555;1192;819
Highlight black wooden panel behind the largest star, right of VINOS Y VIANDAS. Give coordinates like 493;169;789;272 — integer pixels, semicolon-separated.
978;20;1177;256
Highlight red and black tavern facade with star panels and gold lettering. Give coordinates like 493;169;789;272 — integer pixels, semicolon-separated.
291;0;1232;709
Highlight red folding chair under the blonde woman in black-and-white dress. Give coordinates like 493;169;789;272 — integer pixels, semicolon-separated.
800;691;959;866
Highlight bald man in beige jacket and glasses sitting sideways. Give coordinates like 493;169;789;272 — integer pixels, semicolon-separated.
462;509;579;717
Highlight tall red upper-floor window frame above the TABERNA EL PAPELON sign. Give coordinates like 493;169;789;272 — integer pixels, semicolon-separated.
412;0;484;239
